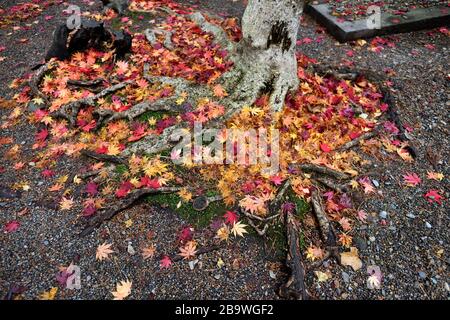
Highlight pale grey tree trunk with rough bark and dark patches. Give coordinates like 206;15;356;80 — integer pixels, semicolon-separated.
224;0;304;112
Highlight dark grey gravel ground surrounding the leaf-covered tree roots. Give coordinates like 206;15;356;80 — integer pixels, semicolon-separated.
0;0;450;299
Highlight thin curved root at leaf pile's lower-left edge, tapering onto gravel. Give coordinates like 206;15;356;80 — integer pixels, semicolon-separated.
80;187;181;237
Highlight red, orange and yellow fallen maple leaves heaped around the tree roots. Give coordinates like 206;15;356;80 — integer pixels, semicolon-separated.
0;1;444;299
